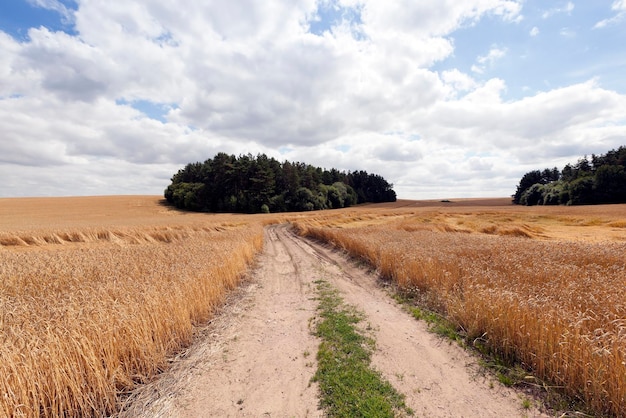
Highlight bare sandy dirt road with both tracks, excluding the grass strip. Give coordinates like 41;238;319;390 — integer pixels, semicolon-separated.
122;225;547;418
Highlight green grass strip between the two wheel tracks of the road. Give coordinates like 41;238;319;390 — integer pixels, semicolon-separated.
313;280;413;417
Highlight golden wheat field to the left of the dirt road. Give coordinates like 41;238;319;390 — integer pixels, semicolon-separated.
0;196;263;417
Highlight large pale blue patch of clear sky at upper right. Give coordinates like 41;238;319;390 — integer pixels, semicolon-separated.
436;0;626;99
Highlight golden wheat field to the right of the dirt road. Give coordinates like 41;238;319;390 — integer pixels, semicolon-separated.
295;202;626;416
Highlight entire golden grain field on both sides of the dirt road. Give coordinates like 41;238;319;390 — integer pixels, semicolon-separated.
0;196;626;416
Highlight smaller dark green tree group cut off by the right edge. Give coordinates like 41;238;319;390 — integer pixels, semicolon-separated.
513;146;626;205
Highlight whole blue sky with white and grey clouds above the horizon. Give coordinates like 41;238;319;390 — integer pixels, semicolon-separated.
0;0;626;199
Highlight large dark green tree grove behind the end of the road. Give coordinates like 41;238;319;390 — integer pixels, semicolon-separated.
165;153;396;213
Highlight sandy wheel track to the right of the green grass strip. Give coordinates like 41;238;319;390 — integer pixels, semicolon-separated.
285;225;548;418
